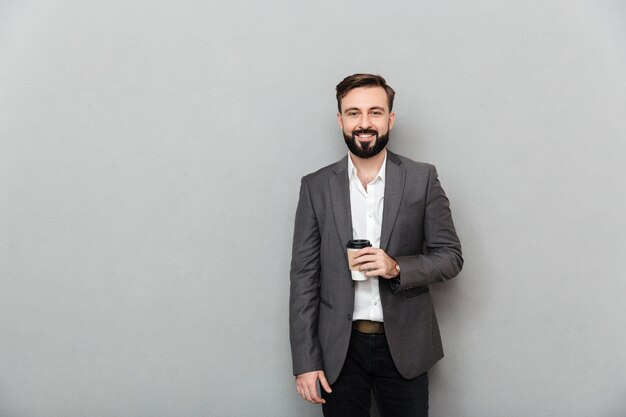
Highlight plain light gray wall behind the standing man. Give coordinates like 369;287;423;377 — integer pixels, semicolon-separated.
0;0;626;417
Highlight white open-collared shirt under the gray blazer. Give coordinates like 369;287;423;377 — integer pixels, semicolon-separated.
348;151;387;321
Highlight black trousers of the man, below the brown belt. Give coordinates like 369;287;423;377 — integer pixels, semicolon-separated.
322;330;428;417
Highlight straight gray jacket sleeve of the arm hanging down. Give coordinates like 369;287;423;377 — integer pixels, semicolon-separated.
289;178;323;375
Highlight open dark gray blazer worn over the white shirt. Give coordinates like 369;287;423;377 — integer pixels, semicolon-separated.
289;151;463;384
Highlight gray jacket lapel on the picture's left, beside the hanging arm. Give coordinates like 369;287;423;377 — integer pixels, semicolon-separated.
329;155;352;255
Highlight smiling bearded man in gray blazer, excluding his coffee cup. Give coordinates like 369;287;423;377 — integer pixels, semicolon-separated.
289;74;463;417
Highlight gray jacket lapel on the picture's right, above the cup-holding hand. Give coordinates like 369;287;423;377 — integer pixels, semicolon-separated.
380;151;406;251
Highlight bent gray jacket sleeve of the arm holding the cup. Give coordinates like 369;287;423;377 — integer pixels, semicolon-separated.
390;166;463;292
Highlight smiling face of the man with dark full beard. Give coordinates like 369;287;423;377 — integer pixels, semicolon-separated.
337;87;395;158
